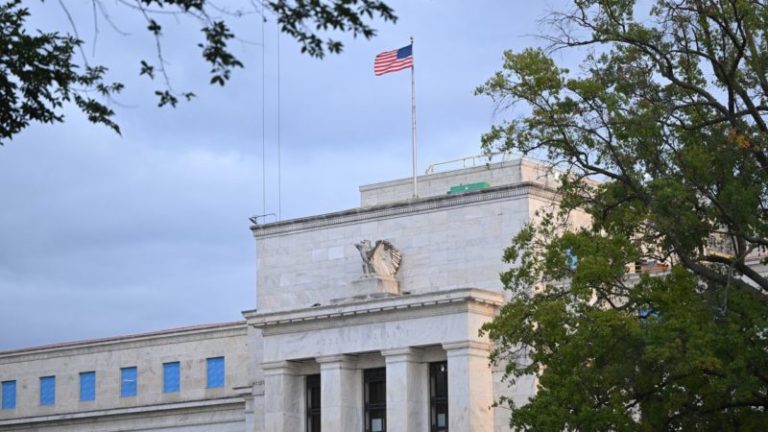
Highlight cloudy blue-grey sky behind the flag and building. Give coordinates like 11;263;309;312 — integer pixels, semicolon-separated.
0;0;562;350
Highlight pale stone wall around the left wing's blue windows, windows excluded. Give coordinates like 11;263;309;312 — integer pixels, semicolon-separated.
0;322;254;430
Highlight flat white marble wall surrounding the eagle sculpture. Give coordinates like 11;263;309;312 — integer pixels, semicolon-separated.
256;196;529;312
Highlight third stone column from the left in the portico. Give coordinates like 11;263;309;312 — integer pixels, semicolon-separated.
381;348;429;432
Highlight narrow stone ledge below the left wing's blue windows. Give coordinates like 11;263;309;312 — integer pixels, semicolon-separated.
0;397;245;428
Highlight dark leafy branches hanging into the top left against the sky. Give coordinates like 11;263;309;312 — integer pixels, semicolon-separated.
0;0;397;145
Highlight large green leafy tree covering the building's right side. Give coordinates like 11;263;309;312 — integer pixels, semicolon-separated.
477;0;768;431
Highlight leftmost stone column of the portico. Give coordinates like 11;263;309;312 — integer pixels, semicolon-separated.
261;361;304;432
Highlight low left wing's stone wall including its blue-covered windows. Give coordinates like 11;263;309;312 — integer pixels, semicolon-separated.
0;321;254;431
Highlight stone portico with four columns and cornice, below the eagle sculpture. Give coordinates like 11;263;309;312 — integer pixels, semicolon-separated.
246;289;503;432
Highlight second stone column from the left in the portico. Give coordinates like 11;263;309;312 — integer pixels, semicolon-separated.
316;355;363;431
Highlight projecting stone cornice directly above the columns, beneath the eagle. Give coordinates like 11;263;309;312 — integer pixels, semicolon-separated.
243;288;503;330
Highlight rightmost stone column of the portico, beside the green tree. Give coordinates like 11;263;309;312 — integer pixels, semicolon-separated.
443;341;494;432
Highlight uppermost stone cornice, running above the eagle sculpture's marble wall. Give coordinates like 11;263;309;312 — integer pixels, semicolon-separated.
251;182;557;238
